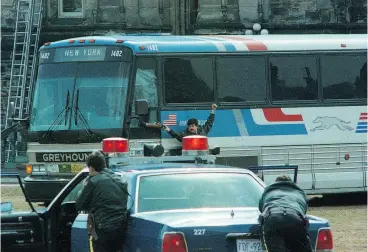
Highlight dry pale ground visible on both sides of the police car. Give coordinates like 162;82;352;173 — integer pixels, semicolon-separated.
1;185;367;252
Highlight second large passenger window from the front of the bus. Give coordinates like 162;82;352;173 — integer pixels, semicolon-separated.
216;56;267;102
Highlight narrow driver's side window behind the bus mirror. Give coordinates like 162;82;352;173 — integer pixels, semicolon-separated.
131;58;158;128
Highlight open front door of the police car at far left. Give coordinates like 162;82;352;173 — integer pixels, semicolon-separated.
1;173;46;252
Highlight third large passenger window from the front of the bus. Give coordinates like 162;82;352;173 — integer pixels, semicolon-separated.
269;55;318;101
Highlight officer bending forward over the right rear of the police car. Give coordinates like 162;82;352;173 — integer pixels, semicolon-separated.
259;175;312;252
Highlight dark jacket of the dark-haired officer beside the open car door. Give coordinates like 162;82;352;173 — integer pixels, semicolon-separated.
75;168;128;228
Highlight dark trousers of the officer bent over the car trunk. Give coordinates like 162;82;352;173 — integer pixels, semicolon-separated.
263;210;312;252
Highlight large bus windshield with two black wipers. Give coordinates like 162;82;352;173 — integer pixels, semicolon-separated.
30;62;130;131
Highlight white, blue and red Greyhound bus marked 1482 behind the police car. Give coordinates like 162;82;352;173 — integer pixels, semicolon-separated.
25;34;368;201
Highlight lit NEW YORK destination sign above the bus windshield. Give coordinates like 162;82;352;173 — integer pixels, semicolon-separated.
39;46;125;64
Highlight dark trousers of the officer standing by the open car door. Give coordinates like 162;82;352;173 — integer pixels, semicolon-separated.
89;226;124;252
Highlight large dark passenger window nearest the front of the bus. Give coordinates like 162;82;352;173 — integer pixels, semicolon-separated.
164;58;214;103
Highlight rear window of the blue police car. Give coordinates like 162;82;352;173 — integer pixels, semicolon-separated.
138;173;263;212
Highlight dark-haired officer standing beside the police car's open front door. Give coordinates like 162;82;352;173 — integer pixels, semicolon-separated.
76;151;128;252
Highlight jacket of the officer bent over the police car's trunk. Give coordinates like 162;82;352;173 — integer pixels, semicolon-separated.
258;181;308;215
